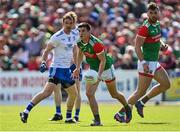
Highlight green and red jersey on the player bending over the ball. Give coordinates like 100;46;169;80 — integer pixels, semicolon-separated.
77;35;113;72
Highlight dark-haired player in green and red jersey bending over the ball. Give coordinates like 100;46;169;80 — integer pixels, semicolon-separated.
73;22;132;126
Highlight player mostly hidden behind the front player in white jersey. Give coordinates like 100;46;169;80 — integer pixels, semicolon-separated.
50;12;82;121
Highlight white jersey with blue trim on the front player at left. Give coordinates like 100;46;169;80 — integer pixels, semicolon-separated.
48;29;79;68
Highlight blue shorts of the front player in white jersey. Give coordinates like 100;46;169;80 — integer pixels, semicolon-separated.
49;67;75;88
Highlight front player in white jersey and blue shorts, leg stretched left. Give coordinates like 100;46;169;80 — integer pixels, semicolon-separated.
20;12;78;123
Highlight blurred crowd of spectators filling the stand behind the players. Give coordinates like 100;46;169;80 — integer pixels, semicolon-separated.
0;0;180;71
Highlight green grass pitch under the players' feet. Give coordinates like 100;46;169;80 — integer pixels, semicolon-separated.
0;104;180;131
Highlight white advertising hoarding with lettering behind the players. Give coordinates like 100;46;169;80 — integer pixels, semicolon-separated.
0;70;161;104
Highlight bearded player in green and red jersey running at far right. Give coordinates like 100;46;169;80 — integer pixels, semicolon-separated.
119;2;170;121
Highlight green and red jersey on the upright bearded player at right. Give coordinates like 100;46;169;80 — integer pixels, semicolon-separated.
138;20;161;61
